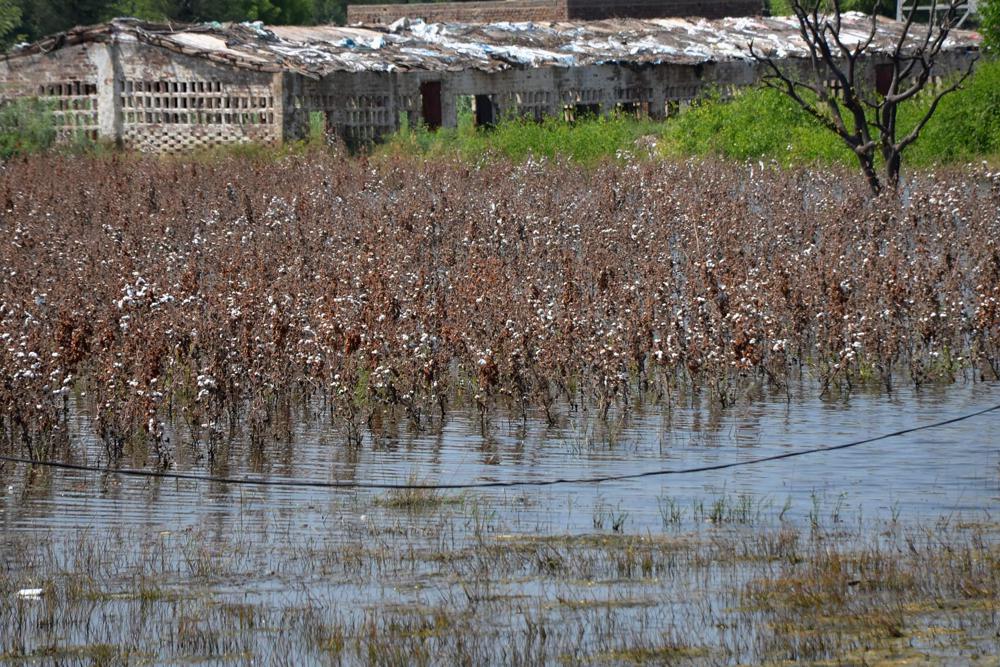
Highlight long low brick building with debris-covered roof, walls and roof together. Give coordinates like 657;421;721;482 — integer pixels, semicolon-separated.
0;14;979;152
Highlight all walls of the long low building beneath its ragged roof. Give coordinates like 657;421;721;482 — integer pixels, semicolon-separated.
0;28;975;153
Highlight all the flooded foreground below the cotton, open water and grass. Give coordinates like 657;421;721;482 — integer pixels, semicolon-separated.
0;383;1000;664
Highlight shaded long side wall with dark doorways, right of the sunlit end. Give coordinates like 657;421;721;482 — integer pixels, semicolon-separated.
283;56;760;146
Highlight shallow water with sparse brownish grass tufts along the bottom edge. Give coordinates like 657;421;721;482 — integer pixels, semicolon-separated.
0;500;1000;665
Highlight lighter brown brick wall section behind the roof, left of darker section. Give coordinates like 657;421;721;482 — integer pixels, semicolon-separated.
347;0;567;25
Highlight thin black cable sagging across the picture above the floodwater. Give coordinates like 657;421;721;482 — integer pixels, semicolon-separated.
0;405;1000;491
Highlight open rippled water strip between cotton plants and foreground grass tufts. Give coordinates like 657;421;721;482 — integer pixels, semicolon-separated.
0;383;1000;535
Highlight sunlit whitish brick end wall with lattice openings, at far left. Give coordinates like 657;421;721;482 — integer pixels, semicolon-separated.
0;42;284;153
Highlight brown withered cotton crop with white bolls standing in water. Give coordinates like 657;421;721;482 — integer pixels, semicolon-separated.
0;154;1000;465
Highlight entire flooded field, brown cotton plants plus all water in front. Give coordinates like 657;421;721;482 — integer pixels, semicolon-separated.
0;154;1000;665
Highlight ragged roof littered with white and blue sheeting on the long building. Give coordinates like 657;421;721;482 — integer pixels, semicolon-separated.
4;12;981;77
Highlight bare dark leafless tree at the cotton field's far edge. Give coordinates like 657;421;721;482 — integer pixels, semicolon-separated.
750;0;975;194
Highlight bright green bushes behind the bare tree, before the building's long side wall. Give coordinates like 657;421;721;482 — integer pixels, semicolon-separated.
377;61;1000;166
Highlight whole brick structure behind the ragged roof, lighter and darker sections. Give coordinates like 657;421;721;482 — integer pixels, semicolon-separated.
347;0;763;25
